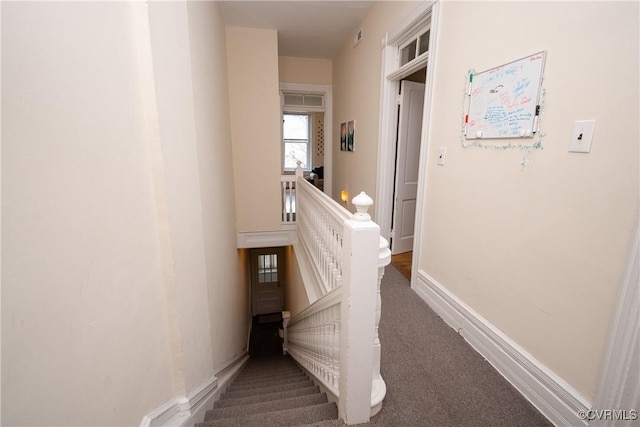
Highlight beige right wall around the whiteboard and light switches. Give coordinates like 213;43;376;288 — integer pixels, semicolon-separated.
419;2;639;401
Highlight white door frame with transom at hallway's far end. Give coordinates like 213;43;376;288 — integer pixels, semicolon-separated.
280;82;333;197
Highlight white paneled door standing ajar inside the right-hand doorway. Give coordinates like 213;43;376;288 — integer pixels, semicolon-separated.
391;81;424;254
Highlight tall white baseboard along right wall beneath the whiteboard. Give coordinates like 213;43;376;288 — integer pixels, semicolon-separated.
412;270;591;426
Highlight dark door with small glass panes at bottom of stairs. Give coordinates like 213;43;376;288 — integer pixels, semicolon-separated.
250;248;284;316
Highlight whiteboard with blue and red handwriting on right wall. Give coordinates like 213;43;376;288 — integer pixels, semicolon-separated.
465;51;546;139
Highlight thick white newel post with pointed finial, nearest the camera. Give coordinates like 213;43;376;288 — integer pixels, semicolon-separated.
338;192;380;425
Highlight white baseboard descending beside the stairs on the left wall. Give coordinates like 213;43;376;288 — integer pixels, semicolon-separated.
140;354;249;427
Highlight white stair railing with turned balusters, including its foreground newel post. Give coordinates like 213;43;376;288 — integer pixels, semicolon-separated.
284;172;391;425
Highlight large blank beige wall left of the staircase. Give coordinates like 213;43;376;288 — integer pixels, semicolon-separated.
2;2;250;425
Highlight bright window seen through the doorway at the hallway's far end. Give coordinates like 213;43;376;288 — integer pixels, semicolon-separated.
282;113;311;171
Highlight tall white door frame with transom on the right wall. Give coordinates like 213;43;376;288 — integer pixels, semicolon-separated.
375;0;440;288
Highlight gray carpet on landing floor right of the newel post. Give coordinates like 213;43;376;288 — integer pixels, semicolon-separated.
361;266;552;427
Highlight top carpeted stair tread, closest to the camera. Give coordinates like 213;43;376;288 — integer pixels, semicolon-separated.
195;403;338;427
